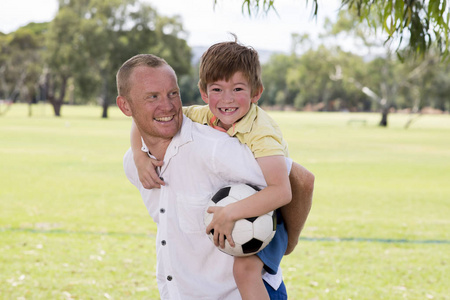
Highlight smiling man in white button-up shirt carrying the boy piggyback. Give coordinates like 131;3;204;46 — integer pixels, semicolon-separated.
117;55;313;300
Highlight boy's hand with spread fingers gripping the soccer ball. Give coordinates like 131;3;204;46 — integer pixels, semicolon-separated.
206;206;235;249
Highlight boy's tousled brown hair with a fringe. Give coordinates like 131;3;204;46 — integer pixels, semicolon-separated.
198;35;263;97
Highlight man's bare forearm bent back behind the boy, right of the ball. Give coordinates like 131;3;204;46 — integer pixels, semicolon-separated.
281;162;314;255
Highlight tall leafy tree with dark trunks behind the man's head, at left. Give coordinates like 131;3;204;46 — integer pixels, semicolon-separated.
47;0;191;118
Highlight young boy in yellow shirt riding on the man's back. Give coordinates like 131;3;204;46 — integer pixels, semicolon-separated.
131;41;298;299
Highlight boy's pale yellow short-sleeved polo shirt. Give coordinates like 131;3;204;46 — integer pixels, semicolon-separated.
183;103;289;158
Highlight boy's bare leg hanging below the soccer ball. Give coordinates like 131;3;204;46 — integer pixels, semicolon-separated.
233;255;270;300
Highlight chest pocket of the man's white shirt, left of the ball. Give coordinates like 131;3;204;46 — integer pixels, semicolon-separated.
176;194;209;234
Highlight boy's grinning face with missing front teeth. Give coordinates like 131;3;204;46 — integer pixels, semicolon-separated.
200;72;263;130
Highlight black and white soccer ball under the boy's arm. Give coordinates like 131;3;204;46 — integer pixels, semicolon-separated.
204;184;277;256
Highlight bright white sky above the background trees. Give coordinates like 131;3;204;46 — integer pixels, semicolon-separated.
0;0;340;53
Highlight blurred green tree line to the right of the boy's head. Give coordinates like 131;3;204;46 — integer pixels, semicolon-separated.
260;37;450;112
